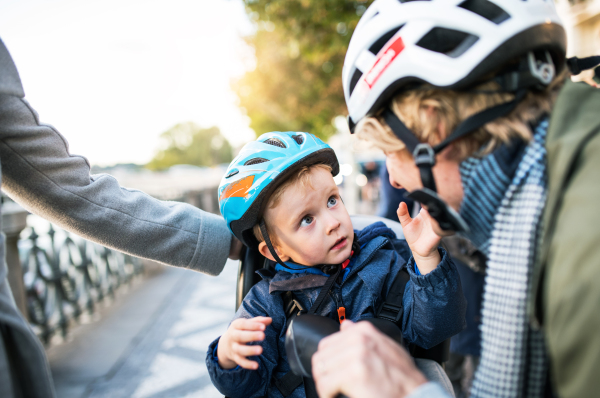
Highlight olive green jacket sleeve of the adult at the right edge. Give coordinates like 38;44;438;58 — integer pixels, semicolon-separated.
544;130;600;397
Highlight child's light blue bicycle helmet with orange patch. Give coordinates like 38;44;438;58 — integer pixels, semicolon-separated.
219;132;339;248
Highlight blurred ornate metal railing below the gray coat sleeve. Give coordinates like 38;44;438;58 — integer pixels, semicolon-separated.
19;225;143;344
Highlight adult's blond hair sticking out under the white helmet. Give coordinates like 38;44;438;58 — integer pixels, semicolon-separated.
356;73;566;160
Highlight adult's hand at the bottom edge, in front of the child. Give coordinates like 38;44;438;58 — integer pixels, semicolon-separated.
312;321;427;398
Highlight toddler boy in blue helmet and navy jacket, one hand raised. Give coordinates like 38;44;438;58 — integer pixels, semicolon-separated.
207;133;466;398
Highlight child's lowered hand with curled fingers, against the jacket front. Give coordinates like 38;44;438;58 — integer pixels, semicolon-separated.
217;316;273;370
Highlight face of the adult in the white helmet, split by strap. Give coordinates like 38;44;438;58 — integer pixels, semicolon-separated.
385;149;463;236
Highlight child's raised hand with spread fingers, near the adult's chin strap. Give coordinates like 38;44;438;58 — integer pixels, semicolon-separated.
397;202;441;275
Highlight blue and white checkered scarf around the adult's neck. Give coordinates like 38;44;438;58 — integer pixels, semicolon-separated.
460;119;548;397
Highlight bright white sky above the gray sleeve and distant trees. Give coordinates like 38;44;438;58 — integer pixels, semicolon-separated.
0;0;254;166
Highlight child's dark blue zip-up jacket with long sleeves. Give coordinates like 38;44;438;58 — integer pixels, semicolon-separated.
206;222;466;398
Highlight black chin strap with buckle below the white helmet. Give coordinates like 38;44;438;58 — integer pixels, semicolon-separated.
382;89;527;233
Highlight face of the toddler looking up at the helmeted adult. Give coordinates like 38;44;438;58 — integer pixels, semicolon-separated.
259;168;354;266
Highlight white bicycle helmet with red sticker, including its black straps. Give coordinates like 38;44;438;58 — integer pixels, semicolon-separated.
342;0;572;232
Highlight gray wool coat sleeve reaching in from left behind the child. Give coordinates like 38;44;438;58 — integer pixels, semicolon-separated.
0;41;231;275
